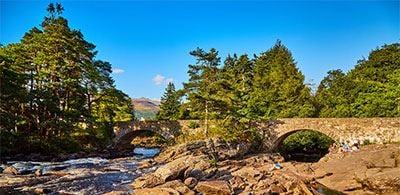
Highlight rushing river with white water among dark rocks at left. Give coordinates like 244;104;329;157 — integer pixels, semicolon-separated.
0;148;160;194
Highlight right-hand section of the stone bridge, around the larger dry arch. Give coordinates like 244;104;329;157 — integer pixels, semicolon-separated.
265;118;400;150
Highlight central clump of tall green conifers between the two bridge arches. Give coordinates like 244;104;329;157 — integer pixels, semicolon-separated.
182;41;316;145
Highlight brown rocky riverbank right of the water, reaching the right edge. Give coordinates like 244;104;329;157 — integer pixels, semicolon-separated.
131;140;400;194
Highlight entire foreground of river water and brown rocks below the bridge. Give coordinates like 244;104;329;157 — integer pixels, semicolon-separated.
0;139;400;195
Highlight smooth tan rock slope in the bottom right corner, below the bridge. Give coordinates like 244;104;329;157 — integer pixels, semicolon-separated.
304;144;400;194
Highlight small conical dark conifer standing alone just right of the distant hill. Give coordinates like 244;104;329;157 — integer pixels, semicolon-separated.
156;83;180;120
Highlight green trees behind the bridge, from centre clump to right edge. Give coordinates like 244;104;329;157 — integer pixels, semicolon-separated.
171;40;400;145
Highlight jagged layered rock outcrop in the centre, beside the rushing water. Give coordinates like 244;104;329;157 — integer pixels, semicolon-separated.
131;139;317;194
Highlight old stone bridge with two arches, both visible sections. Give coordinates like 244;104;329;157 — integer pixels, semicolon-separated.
113;117;400;150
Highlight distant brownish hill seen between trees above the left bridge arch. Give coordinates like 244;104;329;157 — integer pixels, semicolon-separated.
132;97;160;120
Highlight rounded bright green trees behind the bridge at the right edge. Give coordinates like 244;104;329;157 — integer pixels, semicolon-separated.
316;43;400;117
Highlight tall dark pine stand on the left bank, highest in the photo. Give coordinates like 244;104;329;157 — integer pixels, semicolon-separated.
0;4;133;154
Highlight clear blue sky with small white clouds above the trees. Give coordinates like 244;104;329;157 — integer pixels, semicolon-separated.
0;0;400;99
